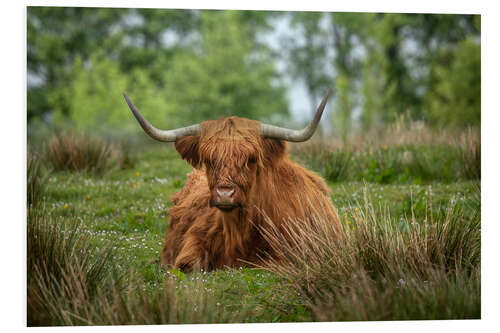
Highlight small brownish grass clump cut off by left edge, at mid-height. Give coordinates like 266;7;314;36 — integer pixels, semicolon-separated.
26;147;47;207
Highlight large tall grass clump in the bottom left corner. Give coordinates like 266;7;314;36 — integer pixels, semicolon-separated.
27;206;117;326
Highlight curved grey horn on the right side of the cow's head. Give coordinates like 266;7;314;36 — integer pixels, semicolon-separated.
260;89;330;142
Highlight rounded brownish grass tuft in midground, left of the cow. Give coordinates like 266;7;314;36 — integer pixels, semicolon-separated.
45;132;119;174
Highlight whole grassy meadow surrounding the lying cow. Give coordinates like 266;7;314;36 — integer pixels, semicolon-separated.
28;126;481;326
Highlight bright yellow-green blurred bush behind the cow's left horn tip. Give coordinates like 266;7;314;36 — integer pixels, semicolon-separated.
49;52;172;134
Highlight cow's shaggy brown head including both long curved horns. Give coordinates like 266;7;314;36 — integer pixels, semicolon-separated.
124;90;330;212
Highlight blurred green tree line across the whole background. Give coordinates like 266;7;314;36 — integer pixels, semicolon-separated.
27;7;481;136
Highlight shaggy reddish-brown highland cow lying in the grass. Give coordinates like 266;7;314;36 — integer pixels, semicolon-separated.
124;91;339;271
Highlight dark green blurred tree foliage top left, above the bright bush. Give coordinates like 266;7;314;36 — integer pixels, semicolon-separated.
27;7;196;119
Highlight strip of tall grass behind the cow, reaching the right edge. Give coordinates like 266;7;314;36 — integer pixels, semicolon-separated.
291;125;481;184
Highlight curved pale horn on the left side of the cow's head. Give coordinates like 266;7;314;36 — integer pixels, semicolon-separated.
123;93;201;142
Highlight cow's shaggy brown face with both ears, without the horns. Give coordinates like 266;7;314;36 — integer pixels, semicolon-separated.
175;117;285;212
